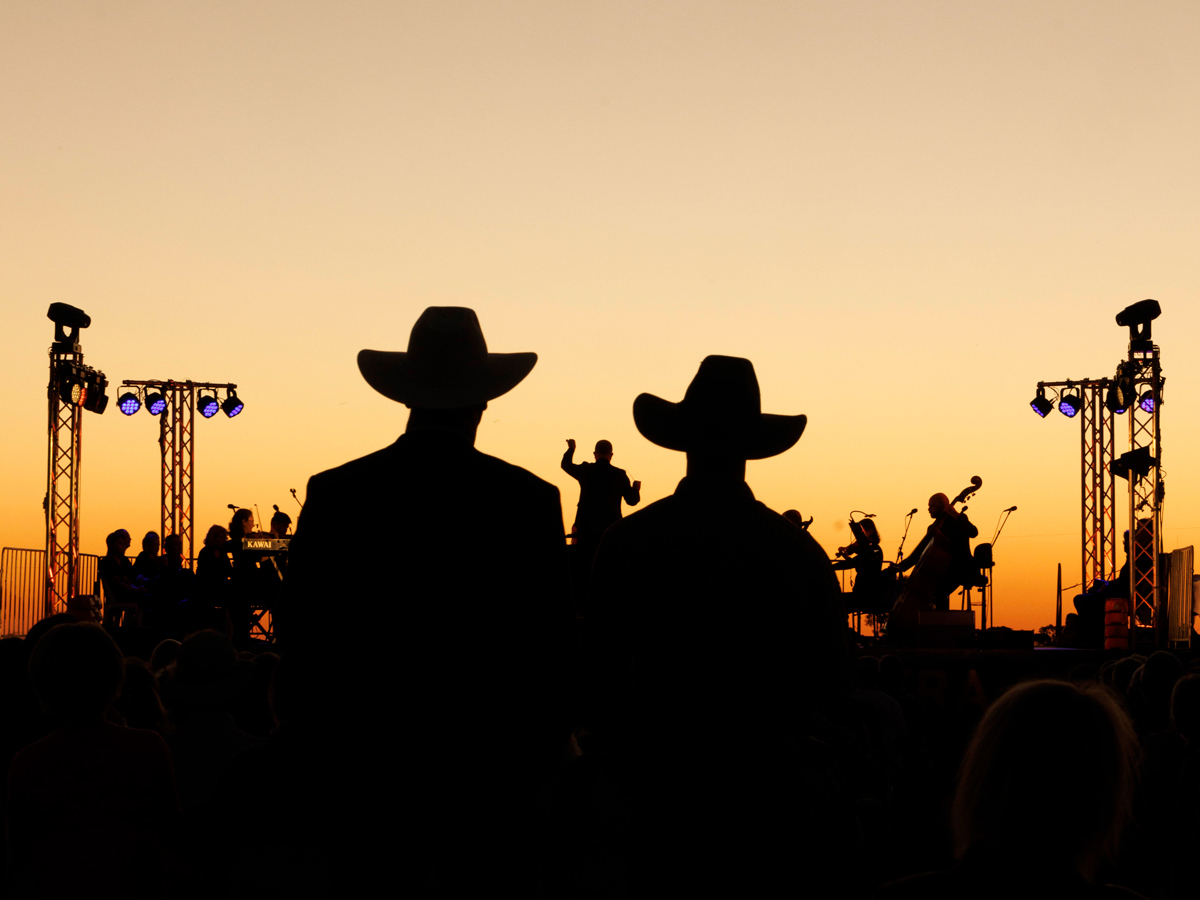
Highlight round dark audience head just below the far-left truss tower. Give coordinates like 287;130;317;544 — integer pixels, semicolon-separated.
29;622;125;725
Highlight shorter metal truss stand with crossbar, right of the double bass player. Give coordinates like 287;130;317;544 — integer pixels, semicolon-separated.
1038;378;1117;590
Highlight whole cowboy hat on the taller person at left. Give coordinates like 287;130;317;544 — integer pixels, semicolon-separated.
359;306;538;409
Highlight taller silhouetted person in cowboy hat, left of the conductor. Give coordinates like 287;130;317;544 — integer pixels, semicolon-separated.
280;307;576;895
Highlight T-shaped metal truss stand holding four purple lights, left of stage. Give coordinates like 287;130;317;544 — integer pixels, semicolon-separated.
121;380;238;566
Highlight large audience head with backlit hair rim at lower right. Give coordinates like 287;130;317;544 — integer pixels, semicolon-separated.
952;680;1138;876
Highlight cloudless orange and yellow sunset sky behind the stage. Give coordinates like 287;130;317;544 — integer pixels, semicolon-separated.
0;0;1200;628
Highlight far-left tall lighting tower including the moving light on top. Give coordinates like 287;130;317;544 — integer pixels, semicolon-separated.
42;304;108;616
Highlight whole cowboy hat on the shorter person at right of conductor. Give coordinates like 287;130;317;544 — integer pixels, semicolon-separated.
634;356;809;460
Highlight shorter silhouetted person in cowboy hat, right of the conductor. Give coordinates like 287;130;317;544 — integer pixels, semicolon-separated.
589;356;851;895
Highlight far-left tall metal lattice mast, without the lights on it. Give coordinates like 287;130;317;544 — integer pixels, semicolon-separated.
43;344;83;616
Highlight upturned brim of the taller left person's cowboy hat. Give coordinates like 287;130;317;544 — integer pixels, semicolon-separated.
359;350;538;409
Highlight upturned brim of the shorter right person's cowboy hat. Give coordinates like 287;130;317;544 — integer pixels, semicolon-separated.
634;394;809;460
